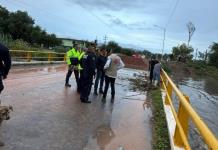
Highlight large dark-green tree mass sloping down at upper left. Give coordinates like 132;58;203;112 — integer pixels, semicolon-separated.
0;6;61;49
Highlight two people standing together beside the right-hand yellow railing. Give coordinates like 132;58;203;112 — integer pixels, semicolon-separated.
149;57;161;86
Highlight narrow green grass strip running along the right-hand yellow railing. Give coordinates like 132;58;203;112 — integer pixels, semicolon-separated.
149;89;170;150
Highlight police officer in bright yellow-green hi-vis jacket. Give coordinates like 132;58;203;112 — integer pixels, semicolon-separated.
65;44;79;87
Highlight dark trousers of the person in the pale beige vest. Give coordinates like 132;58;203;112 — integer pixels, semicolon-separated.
103;75;116;97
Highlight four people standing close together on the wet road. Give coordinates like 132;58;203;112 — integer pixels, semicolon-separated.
65;44;124;103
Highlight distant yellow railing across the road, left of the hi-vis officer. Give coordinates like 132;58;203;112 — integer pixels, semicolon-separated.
10;50;66;62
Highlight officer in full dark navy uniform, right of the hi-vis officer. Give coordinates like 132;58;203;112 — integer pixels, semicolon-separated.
80;45;96;103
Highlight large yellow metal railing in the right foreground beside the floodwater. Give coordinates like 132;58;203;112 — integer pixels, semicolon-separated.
161;70;218;150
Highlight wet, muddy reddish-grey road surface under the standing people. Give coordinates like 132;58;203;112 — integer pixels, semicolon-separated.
0;65;151;150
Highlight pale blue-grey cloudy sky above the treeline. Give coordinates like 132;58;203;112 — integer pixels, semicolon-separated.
0;0;218;53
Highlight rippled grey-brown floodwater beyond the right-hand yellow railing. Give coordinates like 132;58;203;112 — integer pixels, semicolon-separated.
173;77;218;149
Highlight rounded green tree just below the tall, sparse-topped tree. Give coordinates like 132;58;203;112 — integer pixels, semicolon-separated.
172;43;194;60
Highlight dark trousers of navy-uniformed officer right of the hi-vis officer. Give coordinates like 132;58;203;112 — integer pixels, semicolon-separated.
80;75;93;101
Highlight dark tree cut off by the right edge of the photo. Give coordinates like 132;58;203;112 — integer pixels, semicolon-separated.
209;42;218;67
